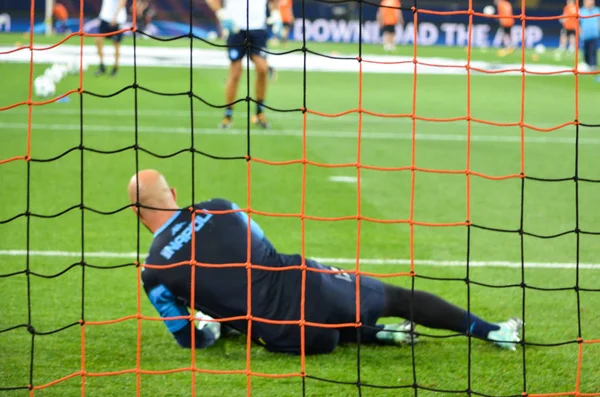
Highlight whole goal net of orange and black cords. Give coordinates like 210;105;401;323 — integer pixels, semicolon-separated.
0;0;600;397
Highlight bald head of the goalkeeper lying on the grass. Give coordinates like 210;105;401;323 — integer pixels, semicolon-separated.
127;170;177;213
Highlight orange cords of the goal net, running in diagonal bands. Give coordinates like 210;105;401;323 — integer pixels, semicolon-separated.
0;0;600;397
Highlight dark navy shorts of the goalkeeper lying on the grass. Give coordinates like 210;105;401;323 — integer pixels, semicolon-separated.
265;259;385;354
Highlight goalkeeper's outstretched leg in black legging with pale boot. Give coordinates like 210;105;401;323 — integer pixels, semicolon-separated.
377;284;522;348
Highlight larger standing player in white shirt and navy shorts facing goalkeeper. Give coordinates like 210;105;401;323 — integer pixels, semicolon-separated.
207;0;280;128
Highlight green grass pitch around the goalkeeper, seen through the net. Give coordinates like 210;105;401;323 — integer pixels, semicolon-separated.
0;36;600;397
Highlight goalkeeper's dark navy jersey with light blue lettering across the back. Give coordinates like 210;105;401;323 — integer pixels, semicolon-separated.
142;199;338;346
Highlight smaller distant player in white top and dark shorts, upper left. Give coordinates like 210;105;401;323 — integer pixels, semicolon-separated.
96;0;127;76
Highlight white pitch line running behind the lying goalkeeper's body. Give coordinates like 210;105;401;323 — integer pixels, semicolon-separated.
0;250;600;270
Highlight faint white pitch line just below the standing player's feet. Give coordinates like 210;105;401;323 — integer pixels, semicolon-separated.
0;123;600;145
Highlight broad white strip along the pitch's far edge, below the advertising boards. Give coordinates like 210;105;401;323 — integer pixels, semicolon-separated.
0;43;587;78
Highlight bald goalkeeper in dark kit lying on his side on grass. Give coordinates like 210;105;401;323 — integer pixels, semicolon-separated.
128;170;522;354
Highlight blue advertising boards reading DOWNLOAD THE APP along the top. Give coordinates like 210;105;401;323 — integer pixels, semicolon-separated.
0;0;580;47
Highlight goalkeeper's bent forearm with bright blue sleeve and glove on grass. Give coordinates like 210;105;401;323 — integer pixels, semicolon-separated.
148;284;221;349
